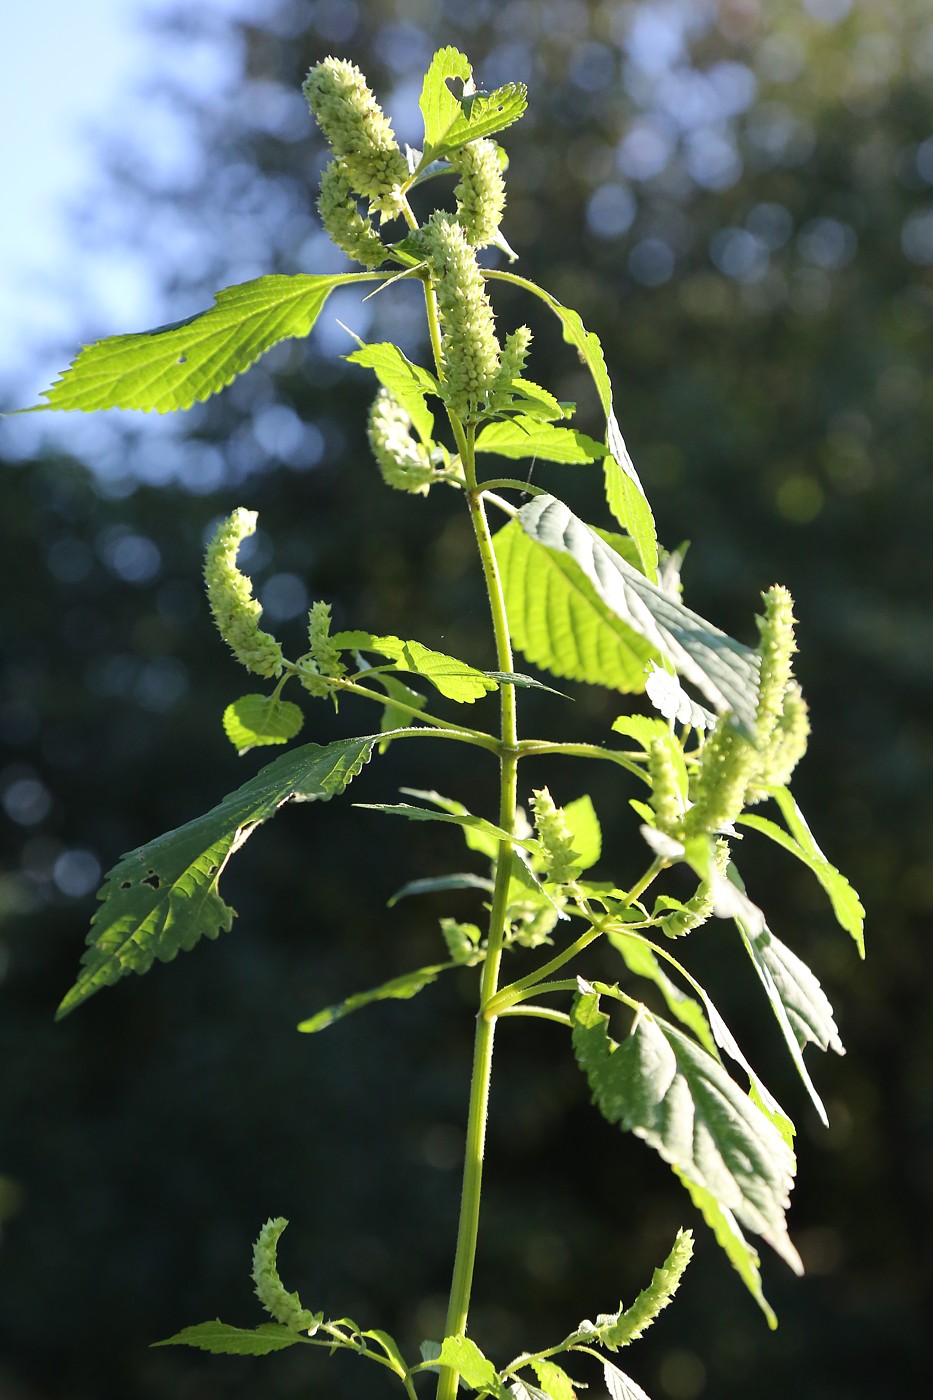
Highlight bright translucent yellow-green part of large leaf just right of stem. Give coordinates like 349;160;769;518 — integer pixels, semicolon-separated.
493;521;657;692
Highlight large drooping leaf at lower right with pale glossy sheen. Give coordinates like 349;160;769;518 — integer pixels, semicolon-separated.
572;993;801;1273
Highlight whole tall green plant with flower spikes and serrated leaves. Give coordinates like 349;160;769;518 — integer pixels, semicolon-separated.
29;49;863;1400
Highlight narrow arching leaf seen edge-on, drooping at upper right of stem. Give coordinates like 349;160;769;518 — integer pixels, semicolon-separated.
486;272;658;582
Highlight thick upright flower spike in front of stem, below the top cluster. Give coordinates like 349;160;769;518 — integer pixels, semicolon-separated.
422;210;499;419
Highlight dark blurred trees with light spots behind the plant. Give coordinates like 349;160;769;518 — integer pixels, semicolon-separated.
0;0;933;1400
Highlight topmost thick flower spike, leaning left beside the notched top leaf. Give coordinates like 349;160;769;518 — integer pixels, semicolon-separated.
303;59;409;218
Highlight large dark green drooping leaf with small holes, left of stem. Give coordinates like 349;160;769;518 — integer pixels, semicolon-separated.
57;735;378;1018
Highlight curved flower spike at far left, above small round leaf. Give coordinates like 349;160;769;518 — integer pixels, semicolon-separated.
205;507;284;676
